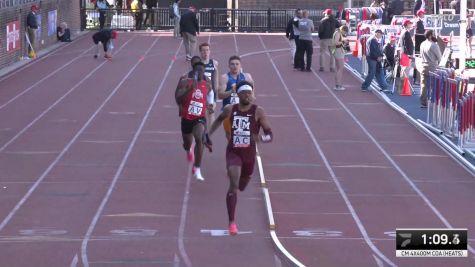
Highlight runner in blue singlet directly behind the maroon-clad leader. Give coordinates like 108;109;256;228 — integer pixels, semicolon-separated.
218;56;255;140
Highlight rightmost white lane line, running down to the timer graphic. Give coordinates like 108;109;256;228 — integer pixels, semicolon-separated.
312;58;475;254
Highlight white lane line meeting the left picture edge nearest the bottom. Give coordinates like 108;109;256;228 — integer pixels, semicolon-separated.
0;37;145;232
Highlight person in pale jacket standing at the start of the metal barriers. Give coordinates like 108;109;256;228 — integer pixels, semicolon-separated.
419;30;442;108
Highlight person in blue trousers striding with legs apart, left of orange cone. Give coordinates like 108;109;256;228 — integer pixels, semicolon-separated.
361;29;388;91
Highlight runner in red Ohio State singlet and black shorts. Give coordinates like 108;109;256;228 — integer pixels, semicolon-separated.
175;61;210;181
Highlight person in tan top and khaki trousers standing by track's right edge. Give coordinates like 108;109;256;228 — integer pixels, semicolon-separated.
332;25;349;91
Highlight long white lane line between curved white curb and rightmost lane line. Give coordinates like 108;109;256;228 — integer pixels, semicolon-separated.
258;36;396;266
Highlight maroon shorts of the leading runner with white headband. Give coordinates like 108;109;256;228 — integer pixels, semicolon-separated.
226;146;256;177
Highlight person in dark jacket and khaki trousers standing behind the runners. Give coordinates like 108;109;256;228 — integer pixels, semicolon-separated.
180;6;200;61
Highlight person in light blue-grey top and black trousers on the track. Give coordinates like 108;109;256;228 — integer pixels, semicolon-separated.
296;10;315;71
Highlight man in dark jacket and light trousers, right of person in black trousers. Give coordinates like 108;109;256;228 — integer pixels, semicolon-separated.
318;9;340;72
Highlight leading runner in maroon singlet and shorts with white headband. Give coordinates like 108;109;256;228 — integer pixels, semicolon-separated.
209;81;273;235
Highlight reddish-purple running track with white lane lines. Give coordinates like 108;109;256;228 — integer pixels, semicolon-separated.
0;33;475;267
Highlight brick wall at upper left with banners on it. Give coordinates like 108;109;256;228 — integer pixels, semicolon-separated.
0;0;80;68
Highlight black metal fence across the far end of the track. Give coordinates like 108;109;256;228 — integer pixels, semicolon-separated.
81;8;323;32
